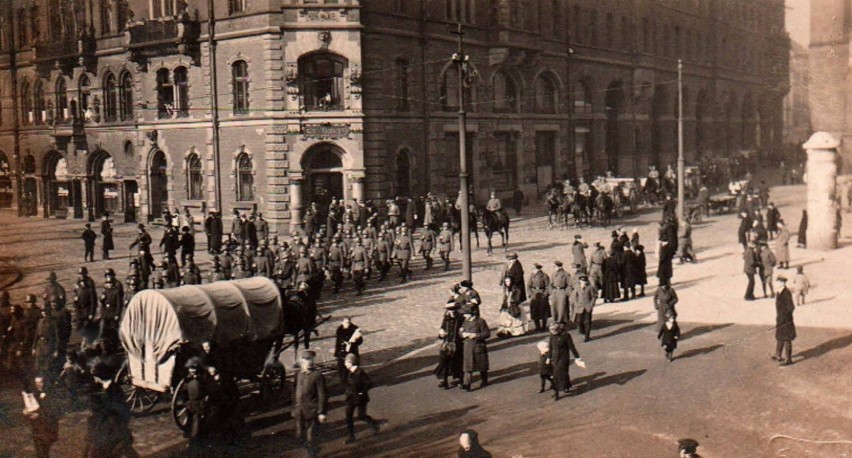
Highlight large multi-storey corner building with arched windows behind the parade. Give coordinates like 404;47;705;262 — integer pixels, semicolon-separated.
0;0;789;233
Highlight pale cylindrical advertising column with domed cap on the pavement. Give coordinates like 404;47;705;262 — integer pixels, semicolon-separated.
803;132;840;250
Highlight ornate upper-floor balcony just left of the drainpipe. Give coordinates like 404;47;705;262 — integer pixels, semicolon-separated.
126;15;201;67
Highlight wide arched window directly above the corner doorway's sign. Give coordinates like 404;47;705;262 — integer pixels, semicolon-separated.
299;53;349;110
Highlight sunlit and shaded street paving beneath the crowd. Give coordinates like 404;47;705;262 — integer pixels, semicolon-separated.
0;182;852;457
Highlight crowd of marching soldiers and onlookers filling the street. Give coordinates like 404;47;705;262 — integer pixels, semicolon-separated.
0;161;809;456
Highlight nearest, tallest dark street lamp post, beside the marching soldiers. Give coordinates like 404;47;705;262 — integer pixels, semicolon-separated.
453;24;473;281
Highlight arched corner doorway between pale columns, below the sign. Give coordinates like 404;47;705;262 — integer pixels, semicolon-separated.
302;144;344;215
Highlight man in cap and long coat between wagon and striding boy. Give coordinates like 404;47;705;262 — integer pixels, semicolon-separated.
293;350;328;456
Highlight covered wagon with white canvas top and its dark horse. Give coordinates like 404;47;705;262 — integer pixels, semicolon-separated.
116;277;327;431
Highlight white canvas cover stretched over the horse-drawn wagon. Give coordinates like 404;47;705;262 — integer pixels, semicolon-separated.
119;277;283;391
